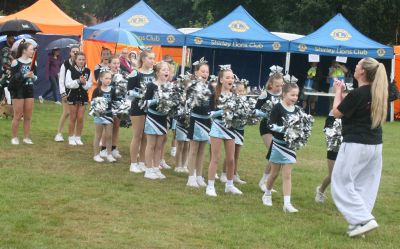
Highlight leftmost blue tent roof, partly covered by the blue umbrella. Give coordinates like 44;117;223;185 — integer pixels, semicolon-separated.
83;1;185;46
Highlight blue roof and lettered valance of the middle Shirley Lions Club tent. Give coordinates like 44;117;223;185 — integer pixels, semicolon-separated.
186;6;289;52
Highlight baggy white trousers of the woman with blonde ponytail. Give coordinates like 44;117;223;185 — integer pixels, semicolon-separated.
331;143;382;225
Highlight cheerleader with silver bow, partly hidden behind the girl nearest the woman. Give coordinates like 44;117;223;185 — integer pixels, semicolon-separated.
256;66;283;192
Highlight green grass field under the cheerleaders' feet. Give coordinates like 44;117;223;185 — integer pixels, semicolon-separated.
0;103;400;249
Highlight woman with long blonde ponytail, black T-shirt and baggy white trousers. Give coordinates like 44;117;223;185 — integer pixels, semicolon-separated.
332;58;388;237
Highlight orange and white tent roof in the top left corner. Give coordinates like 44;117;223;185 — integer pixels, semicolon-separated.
0;0;84;35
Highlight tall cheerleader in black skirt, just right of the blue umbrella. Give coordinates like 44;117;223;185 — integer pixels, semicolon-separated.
128;50;155;173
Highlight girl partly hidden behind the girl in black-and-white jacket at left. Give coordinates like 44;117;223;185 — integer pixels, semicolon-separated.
54;46;80;142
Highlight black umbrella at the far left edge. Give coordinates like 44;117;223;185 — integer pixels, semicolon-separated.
0;19;42;36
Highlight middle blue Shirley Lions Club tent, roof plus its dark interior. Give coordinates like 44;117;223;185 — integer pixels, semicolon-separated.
186;6;289;86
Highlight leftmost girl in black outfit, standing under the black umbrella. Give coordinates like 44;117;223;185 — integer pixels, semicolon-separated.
9;42;37;145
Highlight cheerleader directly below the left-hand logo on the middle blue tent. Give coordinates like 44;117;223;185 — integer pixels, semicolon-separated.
186;58;213;188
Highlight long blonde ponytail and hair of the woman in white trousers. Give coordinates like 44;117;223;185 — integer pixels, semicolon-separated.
362;58;388;129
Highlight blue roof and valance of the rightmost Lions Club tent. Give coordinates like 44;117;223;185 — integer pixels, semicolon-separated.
290;14;393;59
